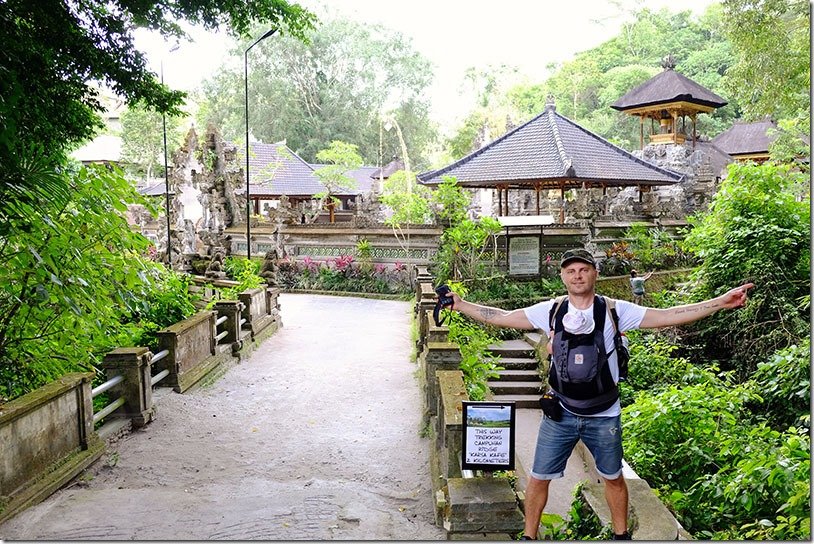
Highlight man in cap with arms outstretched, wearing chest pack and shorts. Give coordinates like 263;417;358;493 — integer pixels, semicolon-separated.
449;249;754;540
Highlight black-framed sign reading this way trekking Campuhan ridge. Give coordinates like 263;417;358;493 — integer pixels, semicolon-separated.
461;401;515;470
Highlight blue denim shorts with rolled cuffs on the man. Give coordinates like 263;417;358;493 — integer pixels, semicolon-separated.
531;410;622;480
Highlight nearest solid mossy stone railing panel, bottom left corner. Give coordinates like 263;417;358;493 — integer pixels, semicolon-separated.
0;373;104;523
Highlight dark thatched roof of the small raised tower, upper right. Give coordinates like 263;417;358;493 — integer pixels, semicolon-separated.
611;69;726;111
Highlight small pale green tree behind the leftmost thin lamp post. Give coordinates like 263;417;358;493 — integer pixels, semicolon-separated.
121;104;182;180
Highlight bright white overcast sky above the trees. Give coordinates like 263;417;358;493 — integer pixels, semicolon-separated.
136;0;714;128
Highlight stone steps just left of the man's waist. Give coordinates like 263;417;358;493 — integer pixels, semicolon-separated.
488;334;543;409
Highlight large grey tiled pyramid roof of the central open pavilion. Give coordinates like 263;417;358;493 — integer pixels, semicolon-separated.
418;104;683;189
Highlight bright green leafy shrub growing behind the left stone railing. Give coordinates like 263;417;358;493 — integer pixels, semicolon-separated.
0;167;157;398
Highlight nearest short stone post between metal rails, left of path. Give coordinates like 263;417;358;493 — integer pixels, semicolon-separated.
101;347;154;427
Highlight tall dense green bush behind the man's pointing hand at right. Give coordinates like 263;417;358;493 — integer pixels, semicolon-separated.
684;163;811;378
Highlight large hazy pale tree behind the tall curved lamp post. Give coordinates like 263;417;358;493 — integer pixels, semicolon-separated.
199;19;435;164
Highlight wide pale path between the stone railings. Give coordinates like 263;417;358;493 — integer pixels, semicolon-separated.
0;295;445;540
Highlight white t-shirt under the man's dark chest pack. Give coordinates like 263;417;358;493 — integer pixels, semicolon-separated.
523;299;647;417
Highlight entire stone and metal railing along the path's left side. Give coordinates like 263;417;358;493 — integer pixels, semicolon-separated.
0;288;282;523
